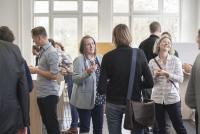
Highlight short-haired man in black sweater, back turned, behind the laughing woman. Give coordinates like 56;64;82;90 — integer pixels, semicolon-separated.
139;21;161;62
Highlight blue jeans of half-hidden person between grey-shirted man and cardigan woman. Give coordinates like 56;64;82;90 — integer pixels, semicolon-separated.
64;76;78;128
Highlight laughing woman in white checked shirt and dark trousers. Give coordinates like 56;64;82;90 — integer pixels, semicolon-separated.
149;36;187;134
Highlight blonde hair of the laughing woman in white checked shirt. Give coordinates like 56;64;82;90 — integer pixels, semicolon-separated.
153;36;175;55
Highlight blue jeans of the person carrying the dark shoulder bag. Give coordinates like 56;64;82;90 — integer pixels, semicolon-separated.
106;103;144;134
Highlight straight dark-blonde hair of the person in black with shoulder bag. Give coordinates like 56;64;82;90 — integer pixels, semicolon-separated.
112;24;132;47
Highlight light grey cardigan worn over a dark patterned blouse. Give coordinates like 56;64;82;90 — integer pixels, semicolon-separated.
70;55;102;109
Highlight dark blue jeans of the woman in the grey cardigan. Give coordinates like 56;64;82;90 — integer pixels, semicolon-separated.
77;105;103;134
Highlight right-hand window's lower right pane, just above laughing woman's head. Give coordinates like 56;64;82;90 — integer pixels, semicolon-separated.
162;17;180;42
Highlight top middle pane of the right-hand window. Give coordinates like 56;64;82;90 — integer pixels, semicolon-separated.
133;0;158;11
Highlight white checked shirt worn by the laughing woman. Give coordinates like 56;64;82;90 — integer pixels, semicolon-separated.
149;55;183;104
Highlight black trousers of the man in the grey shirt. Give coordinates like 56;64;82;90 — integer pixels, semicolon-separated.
37;95;60;134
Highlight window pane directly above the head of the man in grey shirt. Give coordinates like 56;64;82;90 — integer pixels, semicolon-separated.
34;17;49;35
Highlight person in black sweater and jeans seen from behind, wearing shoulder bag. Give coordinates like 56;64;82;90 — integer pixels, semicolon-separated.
98;24;153;134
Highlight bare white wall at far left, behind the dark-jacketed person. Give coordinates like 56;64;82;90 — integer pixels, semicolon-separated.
0;0;32;63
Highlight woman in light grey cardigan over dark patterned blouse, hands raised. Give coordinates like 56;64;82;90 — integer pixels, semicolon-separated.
70;36;105;134
